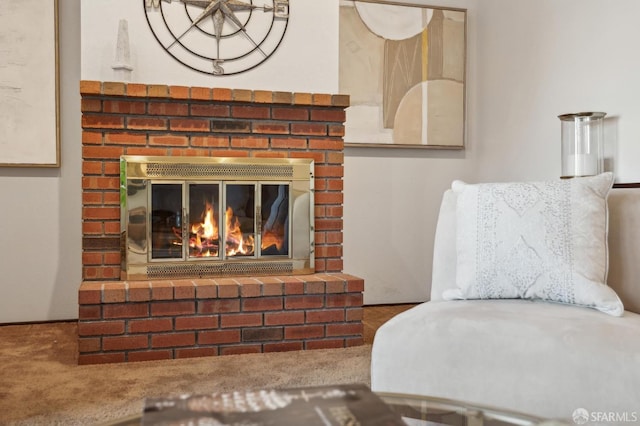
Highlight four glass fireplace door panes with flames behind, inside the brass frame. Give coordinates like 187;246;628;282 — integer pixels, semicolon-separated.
150;182;290;261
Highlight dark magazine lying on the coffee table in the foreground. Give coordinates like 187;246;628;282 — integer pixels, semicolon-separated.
142;384;406;426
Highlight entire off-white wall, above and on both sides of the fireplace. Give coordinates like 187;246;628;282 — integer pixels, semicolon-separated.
0;0;640;323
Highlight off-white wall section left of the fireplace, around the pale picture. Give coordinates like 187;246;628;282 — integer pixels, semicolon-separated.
0;0;82;323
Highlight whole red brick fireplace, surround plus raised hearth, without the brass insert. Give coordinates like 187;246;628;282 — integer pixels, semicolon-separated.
78;81;364;364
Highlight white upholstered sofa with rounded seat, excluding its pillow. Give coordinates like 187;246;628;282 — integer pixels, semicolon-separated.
371;181;640;424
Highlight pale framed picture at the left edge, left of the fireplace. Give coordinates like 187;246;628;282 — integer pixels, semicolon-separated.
0;0;60;167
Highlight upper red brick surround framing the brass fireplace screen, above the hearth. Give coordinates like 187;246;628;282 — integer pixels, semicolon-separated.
80;81;349;281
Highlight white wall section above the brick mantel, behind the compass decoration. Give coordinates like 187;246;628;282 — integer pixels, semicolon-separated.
82;0;338;93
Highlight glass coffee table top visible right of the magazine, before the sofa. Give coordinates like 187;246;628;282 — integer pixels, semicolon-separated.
376;392;570;426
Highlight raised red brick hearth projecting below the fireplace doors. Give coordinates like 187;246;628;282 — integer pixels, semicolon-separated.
78;274;364;364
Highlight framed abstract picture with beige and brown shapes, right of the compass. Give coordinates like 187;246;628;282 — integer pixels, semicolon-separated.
339;0;467;150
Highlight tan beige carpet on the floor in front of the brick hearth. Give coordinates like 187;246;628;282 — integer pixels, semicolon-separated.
0;322;371;426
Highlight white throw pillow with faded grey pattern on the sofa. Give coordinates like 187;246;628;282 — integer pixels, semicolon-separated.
442;173;624;316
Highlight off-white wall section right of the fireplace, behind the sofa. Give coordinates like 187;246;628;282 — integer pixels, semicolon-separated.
352;0;640;304
